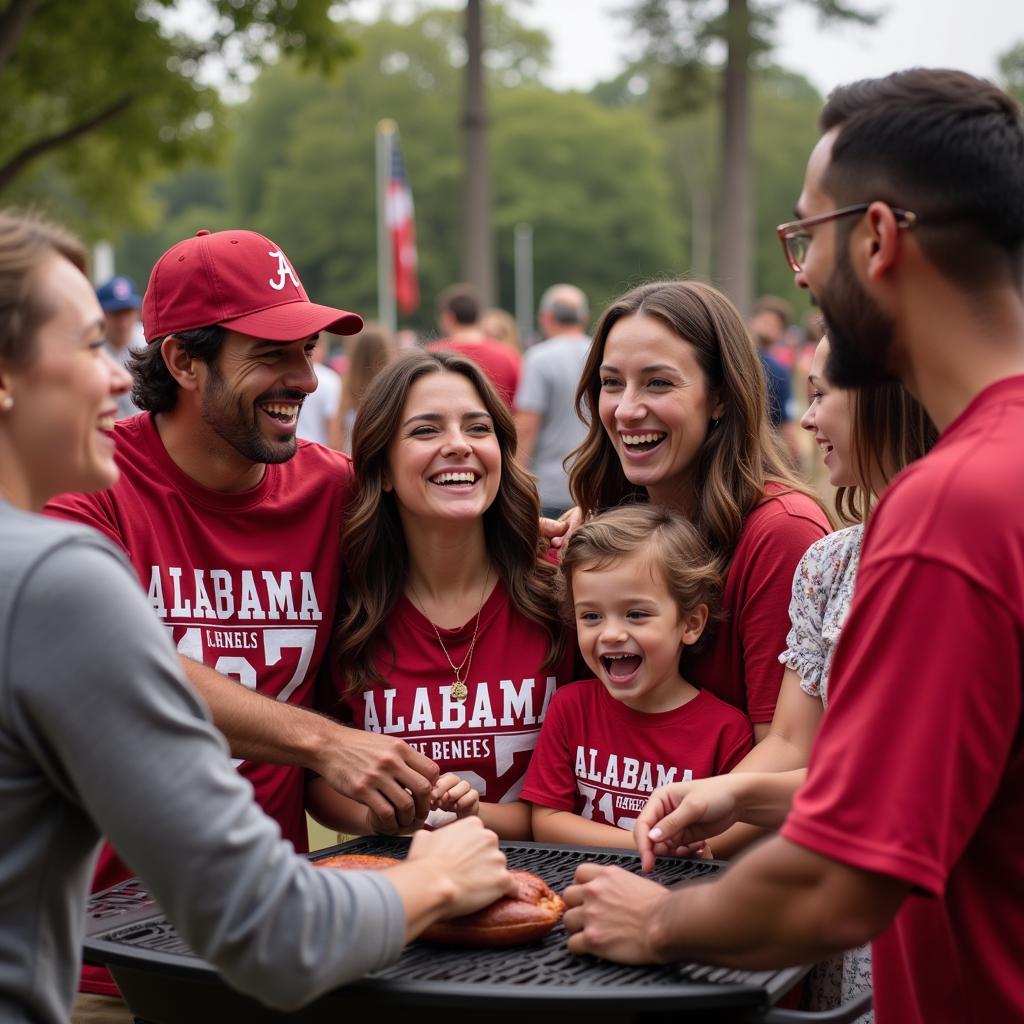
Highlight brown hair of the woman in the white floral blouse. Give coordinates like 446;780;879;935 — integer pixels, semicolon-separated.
836;381;939;523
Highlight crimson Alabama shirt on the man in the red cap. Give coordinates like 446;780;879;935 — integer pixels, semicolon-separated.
45;414;352;994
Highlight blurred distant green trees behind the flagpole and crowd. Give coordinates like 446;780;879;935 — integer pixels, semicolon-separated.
119;2;821;330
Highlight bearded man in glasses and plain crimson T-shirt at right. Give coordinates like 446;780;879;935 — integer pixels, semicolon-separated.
566;70;1024;1024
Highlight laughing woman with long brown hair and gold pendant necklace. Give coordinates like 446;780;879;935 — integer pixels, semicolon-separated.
310;352;575;839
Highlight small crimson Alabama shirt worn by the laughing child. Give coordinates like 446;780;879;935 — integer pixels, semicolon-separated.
522;679;753;831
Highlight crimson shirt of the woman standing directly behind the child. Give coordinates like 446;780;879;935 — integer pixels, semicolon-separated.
683;484;829;722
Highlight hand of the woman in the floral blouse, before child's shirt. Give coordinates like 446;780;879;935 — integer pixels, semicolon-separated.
633;775;743;872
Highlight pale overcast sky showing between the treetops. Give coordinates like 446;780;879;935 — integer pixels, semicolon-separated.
349;0;1024;93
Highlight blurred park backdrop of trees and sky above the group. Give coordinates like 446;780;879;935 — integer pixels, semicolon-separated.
0;0;1024;332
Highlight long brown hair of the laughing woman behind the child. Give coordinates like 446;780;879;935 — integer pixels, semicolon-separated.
569;281;821;571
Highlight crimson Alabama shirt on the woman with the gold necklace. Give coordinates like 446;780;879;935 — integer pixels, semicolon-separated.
328;581;575;803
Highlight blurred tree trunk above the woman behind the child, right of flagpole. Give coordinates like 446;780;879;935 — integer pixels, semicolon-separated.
718;0;754;315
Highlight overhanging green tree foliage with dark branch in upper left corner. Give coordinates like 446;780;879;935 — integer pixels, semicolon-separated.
0;0;351;233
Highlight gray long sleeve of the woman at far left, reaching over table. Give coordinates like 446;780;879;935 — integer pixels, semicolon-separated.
10;540;406;1009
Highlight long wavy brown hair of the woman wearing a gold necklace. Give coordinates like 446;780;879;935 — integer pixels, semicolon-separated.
335;351;565;693
